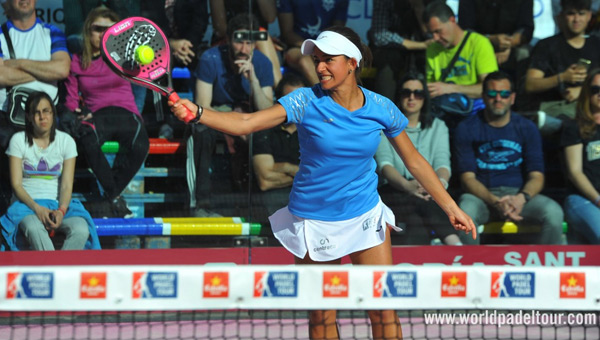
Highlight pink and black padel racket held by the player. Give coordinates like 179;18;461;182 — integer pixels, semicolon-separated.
100;17;195;123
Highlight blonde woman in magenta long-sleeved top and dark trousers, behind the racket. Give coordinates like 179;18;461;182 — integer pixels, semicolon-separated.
61;7;150;217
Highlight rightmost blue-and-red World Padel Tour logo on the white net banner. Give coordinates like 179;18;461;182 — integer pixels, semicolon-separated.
490;272;535;298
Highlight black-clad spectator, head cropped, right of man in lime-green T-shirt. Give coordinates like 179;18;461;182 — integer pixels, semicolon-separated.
458;0;534;81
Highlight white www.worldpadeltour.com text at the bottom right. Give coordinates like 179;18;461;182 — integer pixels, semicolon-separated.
423;310;598;327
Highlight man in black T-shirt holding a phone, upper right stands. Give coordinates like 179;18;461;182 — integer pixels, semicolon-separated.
525;0;600;134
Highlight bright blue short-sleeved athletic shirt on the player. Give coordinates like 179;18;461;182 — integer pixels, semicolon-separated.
279;84;408;221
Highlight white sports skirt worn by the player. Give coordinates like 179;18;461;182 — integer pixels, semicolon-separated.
269;199;402;261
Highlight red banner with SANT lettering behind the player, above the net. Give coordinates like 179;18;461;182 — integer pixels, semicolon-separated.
0;245;600;267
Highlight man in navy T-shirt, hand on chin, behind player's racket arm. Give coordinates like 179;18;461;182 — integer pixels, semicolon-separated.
186;14;273;217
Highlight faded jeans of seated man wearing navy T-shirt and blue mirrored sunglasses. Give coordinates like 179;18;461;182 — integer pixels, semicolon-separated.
458;187;564;244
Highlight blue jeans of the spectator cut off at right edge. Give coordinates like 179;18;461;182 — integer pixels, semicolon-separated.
565;195;600;244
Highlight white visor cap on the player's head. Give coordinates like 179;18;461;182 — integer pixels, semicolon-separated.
300;31;362;64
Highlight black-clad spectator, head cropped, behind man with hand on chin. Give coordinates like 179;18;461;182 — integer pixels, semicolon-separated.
210;0;281;86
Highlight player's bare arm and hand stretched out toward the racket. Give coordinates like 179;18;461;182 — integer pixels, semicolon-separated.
168;99;287;136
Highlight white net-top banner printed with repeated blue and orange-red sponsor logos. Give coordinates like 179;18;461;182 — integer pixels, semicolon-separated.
0;265;600;311
